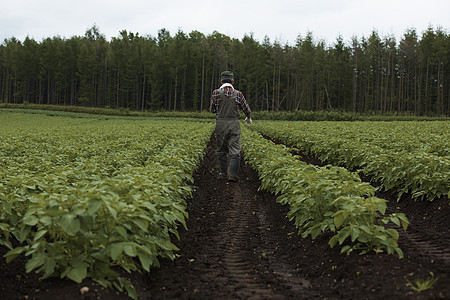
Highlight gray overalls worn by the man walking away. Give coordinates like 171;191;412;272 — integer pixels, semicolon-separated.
216;89;241;178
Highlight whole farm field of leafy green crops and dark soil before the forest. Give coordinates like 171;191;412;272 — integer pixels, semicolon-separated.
0;110;450;299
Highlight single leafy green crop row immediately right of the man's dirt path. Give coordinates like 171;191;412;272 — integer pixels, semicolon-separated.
242;129;408;257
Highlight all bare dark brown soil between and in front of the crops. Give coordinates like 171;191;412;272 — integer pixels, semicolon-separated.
0;139;450;300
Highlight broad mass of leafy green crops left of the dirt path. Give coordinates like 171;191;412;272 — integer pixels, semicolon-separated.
0;114;213;297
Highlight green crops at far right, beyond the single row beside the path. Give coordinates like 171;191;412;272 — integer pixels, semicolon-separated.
254;122;450;201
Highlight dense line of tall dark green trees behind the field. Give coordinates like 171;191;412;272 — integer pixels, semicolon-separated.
0;26;450;116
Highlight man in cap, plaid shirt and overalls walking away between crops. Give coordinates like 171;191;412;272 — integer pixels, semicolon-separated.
210;71;252;182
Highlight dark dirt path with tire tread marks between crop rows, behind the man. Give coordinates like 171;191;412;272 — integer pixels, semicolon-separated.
143;137;309;299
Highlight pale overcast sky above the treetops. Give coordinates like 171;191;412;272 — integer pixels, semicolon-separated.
0;0;450;45
